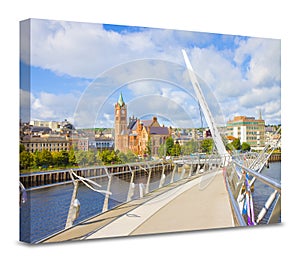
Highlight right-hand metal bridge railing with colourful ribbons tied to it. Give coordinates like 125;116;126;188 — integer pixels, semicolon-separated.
225;155;281;226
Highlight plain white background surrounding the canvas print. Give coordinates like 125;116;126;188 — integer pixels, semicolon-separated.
0;0;300;262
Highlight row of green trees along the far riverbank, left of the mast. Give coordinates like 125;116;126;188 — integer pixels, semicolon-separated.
19;137;223;172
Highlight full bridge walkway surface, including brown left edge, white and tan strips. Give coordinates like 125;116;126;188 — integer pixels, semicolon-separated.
43;169;235;243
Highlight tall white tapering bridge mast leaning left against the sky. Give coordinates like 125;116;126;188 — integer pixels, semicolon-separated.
182;50;230;165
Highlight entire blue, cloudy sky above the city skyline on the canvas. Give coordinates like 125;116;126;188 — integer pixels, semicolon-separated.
20;19;281;128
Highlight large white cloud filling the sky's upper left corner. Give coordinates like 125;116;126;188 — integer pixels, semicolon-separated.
27;20;180;78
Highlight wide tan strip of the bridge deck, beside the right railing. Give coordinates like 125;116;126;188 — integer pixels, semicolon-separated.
131;172;234;235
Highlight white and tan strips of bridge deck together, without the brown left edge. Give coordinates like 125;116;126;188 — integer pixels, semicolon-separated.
89;171;234;239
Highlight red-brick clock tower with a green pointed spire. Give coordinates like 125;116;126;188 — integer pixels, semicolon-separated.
115;93;128;152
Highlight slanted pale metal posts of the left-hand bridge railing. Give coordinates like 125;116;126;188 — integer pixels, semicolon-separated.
66;155;227;228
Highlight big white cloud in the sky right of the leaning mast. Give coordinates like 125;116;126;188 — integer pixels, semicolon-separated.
190;38;281;123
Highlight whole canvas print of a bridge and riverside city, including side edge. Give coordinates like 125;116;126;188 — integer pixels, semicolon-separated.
19;19;281;244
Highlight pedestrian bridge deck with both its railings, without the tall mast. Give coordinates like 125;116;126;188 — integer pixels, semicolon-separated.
27;149;281;243
